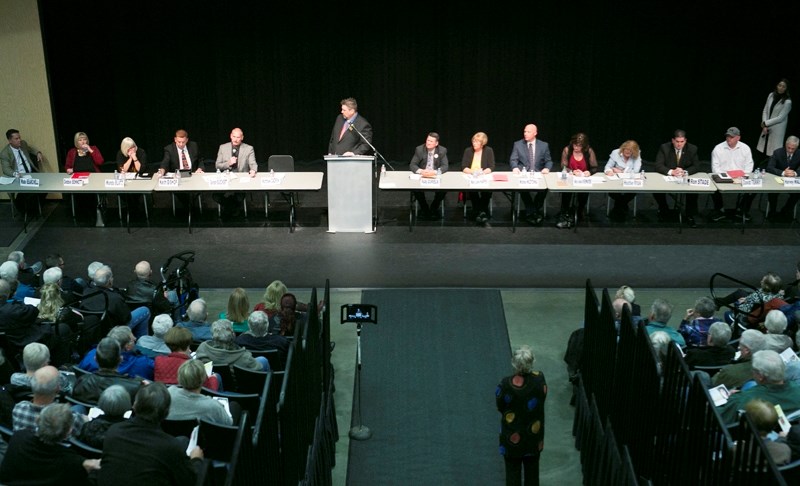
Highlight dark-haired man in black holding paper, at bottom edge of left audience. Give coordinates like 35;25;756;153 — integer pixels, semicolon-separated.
97;382;203;486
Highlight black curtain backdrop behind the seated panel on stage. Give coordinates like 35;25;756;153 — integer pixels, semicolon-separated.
39;0;800;169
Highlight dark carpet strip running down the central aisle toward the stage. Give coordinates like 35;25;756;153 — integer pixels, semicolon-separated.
345;289;510;486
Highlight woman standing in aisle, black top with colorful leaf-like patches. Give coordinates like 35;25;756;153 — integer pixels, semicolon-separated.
495;345;547;486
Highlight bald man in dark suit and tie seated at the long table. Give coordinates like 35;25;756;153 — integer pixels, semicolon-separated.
509;123;553;225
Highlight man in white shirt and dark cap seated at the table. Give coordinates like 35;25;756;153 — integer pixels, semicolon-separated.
710;127;755;221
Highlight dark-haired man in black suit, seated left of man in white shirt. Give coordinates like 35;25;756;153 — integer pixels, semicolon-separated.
653;130;700;228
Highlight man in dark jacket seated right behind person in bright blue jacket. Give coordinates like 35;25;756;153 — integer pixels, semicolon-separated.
72;337;147;404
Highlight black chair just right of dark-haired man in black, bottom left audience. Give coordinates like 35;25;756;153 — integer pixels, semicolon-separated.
197;412;247;486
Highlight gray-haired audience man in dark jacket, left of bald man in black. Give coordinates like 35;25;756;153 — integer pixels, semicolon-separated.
81;265;150;338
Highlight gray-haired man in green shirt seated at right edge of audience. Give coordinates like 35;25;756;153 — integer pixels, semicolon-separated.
720;349;800;424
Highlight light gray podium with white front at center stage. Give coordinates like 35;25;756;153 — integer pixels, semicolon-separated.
325;155;375;233
